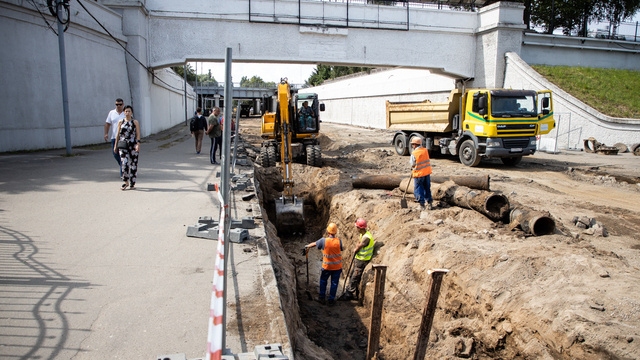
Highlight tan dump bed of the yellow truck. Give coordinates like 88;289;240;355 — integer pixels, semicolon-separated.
386;89;462;133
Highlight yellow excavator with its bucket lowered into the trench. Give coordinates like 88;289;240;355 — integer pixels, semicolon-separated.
257;78;324;234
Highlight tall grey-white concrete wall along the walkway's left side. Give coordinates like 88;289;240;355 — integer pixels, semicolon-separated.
0;0;194;152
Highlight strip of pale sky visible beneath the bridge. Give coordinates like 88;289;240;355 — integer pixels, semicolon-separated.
190;62;316;84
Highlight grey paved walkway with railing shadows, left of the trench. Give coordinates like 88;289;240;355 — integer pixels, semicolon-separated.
0;125;289;359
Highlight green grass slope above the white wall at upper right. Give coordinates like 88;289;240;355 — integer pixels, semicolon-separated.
532;65;640;119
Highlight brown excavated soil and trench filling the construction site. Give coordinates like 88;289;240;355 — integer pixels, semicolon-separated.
240;117;640;360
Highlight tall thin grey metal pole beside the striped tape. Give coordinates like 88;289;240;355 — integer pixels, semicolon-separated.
220;47;233;353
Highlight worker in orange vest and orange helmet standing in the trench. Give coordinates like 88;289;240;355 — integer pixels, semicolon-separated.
303;223;343;306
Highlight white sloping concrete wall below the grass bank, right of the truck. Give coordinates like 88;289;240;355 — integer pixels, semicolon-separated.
504;53;640;149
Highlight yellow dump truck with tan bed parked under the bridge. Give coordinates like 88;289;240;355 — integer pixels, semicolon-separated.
386;89;555;166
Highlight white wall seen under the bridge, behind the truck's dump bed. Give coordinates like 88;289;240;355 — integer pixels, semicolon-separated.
299;69;455;129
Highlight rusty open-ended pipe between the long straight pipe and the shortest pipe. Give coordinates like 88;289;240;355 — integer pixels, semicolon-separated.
431;181;509;221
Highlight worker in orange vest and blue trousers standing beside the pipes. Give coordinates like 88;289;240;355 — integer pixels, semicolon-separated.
411;136;433;210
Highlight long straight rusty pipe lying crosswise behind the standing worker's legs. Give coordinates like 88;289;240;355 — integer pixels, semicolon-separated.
351;175;490;193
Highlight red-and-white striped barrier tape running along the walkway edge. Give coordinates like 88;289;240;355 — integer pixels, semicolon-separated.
206;184;227;360
